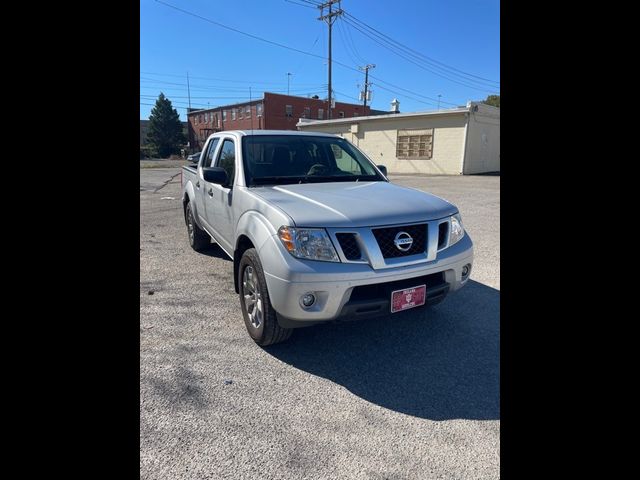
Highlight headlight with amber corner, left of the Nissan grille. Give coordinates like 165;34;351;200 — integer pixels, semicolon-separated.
278;226;340;262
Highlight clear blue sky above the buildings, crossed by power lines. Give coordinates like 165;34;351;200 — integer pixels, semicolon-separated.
140;0;500;120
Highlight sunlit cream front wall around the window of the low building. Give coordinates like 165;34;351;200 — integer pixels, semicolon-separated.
298;112;466;175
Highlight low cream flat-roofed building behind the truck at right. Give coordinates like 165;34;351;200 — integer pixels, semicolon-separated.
297;102;500;175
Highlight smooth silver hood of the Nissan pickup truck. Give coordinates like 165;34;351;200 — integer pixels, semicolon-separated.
251;182;458;227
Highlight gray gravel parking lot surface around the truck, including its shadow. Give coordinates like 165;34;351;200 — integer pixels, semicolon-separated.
140;168;500;480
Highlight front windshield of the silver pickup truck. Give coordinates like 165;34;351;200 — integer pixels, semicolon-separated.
242;135;384;186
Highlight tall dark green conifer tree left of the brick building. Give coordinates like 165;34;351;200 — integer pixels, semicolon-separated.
147;93;185;158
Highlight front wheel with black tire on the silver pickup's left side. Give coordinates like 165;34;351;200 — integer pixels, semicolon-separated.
238;248;293;347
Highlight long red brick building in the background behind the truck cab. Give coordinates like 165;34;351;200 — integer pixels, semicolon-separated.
187;92;371;152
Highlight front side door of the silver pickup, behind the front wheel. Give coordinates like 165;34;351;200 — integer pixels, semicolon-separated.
205;138;236;252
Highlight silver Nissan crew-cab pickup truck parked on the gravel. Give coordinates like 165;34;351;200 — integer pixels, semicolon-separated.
182;130;473;346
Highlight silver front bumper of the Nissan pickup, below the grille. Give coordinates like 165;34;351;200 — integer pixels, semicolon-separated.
259;230;473;327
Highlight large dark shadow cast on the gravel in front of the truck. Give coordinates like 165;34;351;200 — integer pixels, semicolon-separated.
265;280;500;420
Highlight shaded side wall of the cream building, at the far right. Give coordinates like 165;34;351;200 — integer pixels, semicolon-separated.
464;104;500;175
